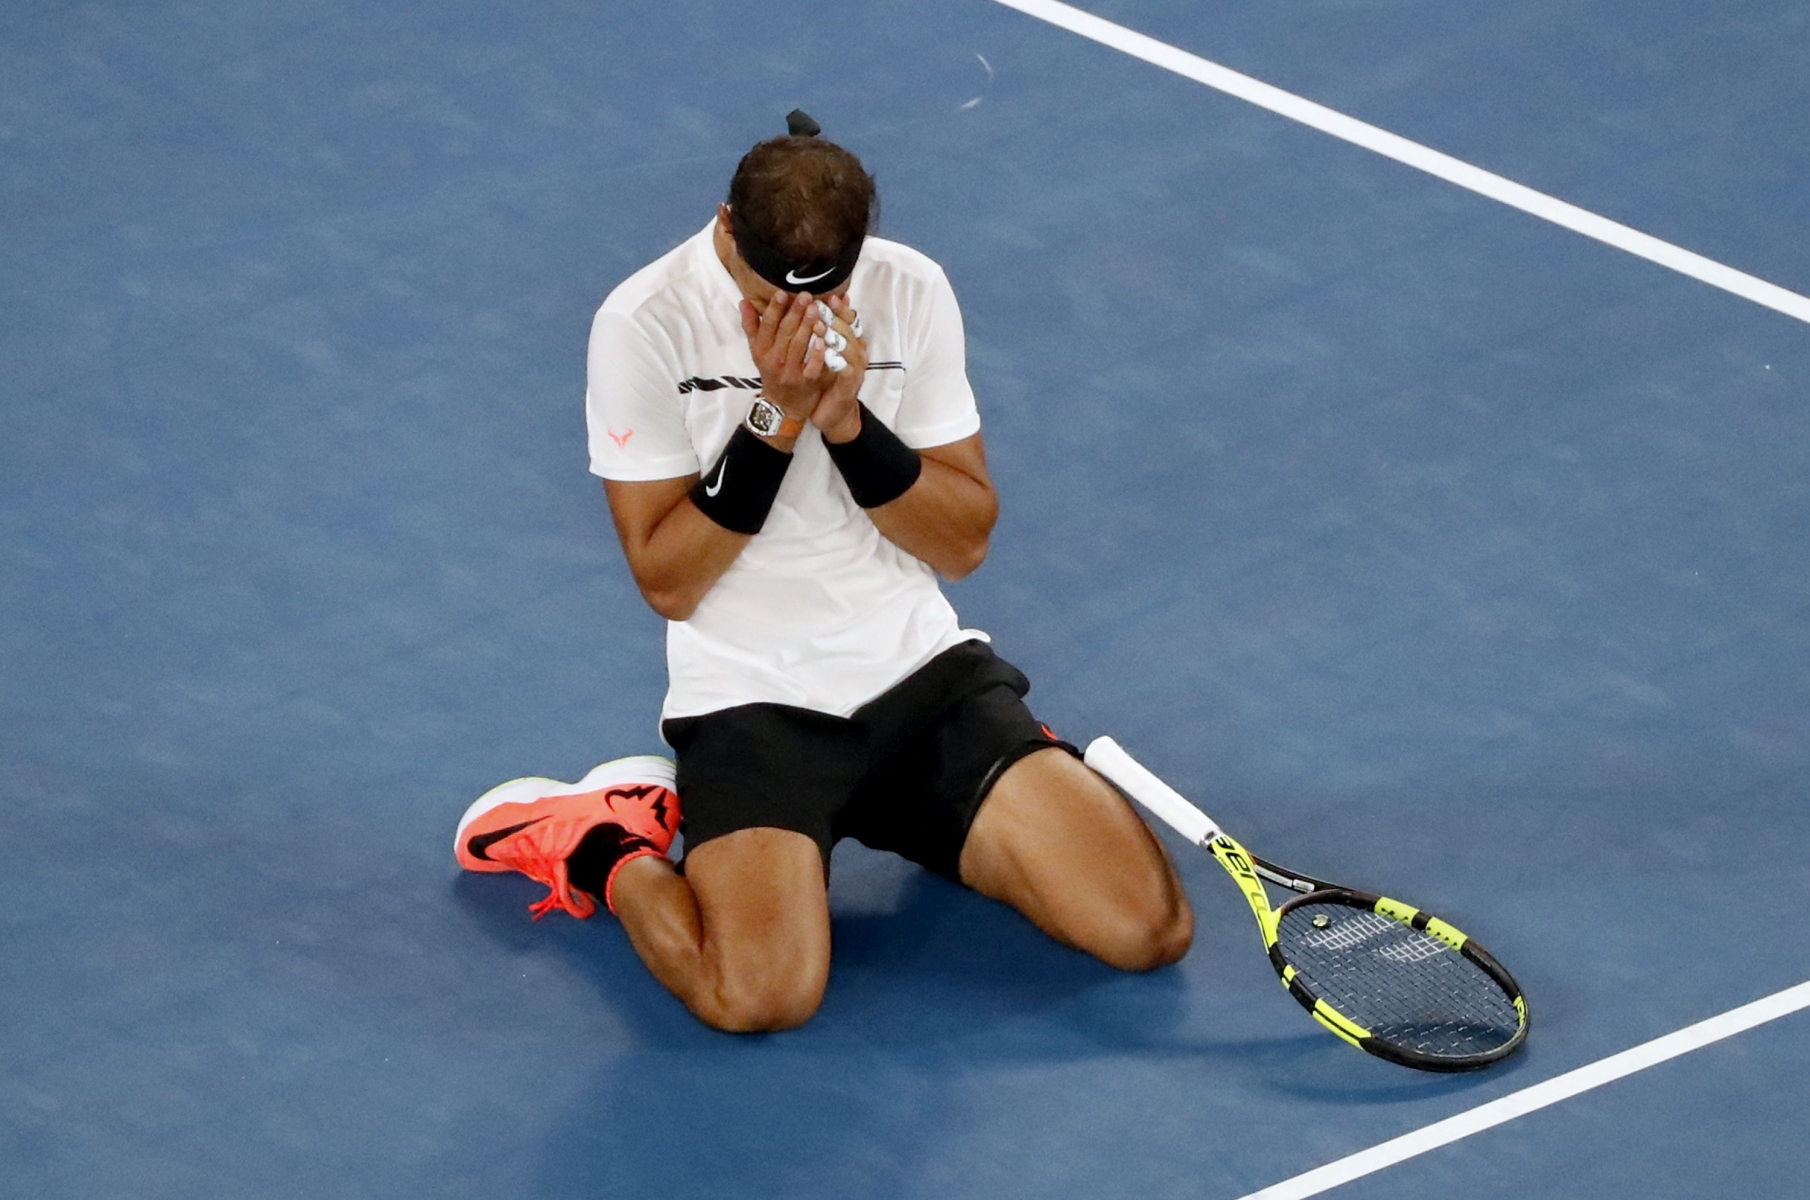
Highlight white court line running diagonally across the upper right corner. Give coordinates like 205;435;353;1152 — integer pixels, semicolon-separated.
996;0;1810;324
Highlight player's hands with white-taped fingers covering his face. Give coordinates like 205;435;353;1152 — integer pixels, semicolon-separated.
742;291;867;443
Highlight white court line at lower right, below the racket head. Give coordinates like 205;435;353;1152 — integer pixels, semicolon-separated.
1240;981;1810;1200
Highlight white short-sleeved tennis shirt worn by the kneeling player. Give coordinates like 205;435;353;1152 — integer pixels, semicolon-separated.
585;223;986;719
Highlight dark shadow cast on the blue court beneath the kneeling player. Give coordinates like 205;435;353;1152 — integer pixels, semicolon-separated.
451;847;1482;1196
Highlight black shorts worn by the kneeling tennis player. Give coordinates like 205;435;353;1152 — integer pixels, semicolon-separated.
661;641;1079;880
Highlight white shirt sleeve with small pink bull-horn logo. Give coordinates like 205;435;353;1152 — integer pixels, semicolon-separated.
585;311;699;481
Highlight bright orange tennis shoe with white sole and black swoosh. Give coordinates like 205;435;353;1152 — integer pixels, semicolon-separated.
453;755;679;921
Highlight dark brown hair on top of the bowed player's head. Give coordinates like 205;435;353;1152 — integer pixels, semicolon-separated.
729;138;880;262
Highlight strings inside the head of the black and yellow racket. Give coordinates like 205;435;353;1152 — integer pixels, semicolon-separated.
1278;903;1520;1059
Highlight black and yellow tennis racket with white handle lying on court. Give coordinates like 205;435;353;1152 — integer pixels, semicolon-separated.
1086;737;1528;1071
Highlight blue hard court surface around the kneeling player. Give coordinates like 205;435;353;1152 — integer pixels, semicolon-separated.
0;0;1810;1200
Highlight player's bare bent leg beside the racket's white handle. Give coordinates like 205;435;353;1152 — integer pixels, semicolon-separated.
961;748;1195;970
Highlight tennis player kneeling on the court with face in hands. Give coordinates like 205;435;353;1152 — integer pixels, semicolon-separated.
456;112;1193;1032
